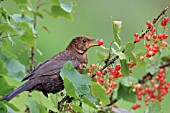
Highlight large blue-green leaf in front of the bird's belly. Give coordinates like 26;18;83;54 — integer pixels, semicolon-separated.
60;62;91;95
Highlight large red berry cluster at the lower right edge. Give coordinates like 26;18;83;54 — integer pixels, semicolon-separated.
132;68;170;110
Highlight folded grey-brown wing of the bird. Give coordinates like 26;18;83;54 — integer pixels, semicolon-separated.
22;51;80;81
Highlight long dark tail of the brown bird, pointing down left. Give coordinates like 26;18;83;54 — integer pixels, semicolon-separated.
1;81;37;101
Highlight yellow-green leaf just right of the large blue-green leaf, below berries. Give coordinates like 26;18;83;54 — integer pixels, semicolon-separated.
90;81;109;105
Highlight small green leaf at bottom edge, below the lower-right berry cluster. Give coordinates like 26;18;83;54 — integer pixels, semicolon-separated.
145;101;163;113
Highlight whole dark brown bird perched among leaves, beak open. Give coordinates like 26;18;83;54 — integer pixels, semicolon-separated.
1;36;99;101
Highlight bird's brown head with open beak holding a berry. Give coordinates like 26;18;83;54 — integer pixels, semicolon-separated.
67;36;100;54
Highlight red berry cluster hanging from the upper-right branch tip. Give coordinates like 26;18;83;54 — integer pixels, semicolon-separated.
134;17;169;60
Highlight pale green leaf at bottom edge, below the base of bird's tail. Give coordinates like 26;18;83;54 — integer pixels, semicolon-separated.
27;97;41;113
